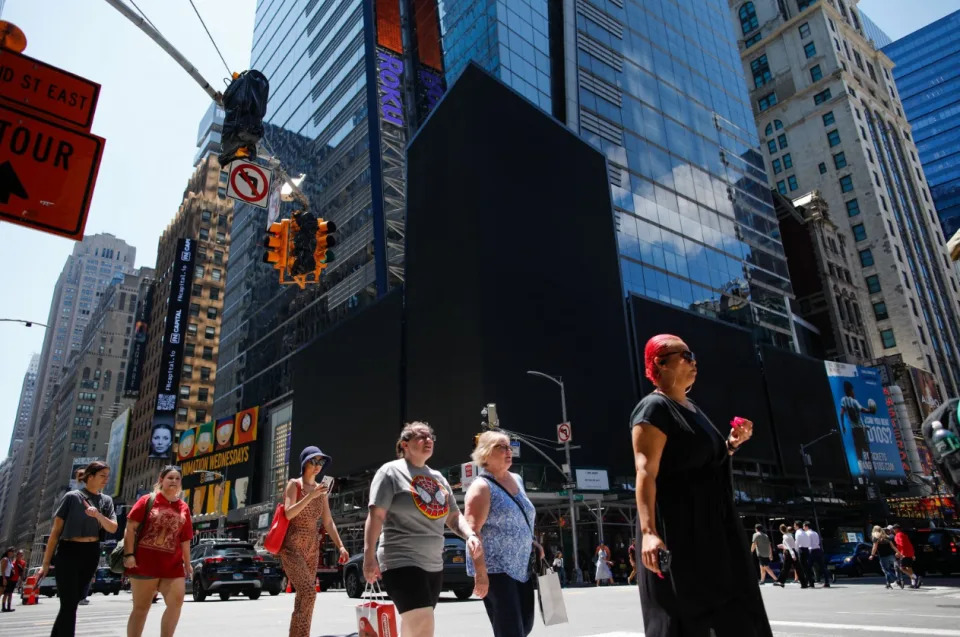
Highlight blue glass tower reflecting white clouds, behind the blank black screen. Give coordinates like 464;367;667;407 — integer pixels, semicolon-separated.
441;0;795;346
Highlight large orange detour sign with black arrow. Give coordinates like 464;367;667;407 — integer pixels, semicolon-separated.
0;103;104;239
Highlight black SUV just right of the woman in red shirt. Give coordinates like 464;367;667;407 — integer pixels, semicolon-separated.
190;539;263;602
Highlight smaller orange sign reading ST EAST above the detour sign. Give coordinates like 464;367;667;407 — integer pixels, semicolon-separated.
0;49;100;132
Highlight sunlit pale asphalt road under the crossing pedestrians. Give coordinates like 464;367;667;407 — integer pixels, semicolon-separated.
7;577;960;637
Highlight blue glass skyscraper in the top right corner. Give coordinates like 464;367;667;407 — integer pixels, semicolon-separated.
883;11;960;237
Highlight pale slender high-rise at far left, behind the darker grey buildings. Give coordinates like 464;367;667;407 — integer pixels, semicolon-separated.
10;233;137;548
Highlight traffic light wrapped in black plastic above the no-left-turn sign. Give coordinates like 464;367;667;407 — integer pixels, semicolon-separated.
219;69;270;167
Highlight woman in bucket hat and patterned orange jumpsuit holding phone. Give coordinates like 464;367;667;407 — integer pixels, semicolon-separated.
280;446;350;637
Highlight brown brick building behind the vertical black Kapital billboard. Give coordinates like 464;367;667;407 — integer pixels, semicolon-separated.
119;153;233;504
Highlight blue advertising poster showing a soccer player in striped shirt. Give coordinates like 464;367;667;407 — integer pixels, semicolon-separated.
824;361;906;483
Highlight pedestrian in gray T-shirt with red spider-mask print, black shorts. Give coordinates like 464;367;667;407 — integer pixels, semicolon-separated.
363;422;482;637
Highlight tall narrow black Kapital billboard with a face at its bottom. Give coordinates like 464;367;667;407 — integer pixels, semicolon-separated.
149;239;195;460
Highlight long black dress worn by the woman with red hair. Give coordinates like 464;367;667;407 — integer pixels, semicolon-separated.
630;393;773;637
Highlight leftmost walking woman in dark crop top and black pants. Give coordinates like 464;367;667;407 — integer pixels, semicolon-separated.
37;462;117;637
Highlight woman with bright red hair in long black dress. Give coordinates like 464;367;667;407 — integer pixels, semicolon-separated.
630;334;773;637
